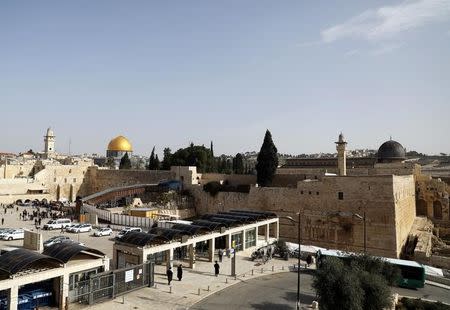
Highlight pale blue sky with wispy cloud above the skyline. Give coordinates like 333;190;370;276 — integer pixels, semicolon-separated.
0;0;450;155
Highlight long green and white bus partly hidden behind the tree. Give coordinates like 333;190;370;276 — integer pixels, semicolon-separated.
317;249;425;288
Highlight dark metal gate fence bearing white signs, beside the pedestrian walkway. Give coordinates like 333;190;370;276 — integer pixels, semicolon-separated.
69;262;154;305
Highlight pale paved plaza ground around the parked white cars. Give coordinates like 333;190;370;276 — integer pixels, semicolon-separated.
0;206;118;259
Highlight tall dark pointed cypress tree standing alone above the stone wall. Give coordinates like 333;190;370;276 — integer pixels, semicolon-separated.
256;130;278;186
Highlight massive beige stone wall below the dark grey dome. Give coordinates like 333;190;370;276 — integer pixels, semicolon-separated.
187;175;415;257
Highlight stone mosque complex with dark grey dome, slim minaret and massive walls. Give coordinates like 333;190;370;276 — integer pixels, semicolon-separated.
173;134;430;257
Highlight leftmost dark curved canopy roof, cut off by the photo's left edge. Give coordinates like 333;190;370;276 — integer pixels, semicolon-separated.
0;249;64;276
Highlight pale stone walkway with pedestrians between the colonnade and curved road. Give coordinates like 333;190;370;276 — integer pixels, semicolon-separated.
69;251;304;310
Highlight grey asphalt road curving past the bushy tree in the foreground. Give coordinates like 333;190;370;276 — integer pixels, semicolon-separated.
191;272;450;310
